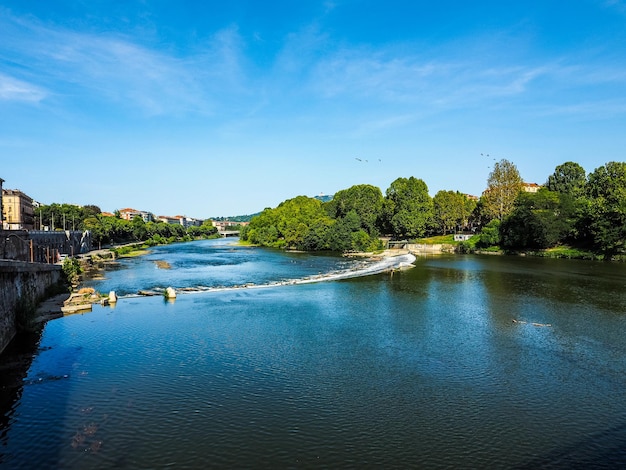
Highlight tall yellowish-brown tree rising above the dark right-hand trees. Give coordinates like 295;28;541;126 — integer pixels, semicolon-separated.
482;159;522;221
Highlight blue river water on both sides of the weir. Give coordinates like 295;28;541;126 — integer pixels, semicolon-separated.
0;240;626;469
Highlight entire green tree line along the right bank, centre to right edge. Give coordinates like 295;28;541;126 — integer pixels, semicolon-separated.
241;159;626;259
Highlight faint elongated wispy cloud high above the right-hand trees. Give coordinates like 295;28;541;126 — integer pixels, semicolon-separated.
312;51;549;108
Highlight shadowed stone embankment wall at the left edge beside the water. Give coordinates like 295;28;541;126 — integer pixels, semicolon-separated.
0;260;61;353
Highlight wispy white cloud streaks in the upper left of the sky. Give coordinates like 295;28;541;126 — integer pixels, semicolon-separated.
0;12;249;115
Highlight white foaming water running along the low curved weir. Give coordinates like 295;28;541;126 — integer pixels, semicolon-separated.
125;253;416;297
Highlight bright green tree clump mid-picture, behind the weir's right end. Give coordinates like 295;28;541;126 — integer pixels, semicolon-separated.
241;177;476;252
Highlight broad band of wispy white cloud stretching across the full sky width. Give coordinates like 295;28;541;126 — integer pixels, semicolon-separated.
0;6;626;128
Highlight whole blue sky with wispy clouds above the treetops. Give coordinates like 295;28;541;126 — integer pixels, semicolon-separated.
0;0;626;218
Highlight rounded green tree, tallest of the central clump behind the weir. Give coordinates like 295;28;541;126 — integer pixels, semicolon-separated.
384;176;433;238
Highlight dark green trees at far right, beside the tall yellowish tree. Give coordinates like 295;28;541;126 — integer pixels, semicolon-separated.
480;162;626;259
